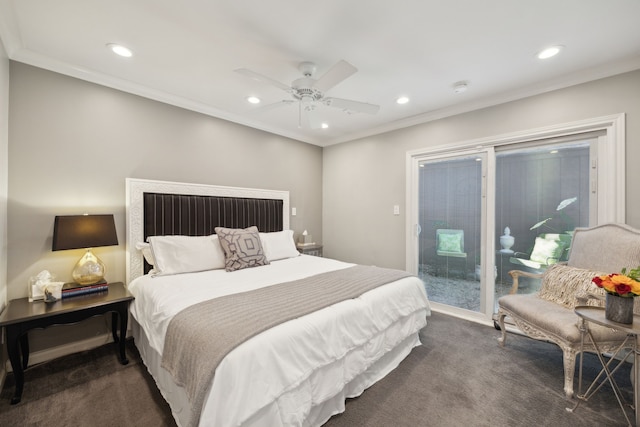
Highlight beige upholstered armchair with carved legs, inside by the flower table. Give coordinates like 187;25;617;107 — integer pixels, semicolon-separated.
498;224;640;398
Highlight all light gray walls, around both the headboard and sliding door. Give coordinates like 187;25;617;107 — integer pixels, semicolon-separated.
7;61;640;349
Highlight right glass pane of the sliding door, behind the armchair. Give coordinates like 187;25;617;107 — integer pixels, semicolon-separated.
495;137;598;301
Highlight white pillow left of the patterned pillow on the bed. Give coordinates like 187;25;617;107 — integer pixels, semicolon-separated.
147;234;224;275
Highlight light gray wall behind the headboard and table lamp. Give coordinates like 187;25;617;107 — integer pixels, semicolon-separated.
7;61;322;352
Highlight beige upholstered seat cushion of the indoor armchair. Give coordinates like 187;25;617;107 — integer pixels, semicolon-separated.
498;294;626;344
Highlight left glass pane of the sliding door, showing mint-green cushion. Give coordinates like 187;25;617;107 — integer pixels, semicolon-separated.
418;154;484;311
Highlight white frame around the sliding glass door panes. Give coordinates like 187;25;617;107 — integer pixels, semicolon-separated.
405;113;626;324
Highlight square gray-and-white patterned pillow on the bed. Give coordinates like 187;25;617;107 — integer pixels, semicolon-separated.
215;226;269;271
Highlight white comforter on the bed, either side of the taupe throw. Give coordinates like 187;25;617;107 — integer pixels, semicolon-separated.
129;256;430;427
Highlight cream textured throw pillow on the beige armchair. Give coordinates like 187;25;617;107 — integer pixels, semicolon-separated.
539;264;607;309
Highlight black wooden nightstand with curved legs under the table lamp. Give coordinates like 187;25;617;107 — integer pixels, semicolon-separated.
0;282;133;405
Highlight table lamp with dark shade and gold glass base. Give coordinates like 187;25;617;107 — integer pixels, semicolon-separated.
51;215;118;285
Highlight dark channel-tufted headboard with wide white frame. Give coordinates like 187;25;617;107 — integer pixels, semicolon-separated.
127;178;289;283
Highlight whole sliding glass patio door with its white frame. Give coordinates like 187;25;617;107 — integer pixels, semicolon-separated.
407;116;625;320
